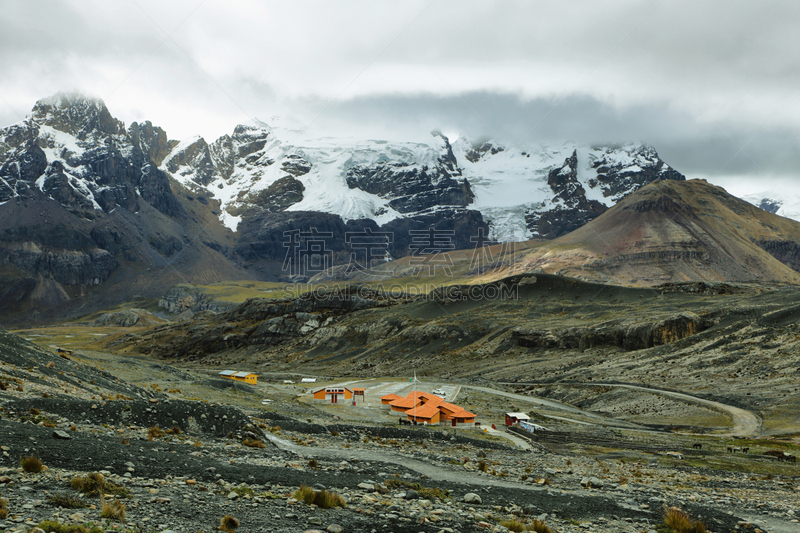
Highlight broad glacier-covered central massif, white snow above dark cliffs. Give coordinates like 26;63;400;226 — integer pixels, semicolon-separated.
161;121;684;241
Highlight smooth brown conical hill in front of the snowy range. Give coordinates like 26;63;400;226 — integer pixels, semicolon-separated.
516;180;800;285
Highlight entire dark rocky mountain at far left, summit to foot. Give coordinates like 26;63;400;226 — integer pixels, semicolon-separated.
0;94;250;322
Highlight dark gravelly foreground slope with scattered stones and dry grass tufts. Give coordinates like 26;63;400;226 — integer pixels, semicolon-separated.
0;331;800;533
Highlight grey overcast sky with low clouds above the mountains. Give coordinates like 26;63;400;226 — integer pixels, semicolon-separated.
0;0;800;193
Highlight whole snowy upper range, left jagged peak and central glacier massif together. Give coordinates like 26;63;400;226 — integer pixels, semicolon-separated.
0;94;684;245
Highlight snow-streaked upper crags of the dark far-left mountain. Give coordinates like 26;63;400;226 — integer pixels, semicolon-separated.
0;94;180;216
